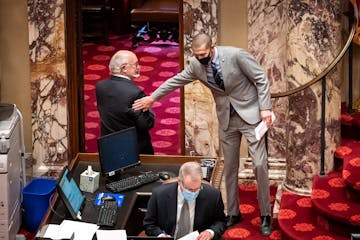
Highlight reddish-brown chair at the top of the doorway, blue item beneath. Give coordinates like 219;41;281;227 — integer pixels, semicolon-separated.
130;0;179;48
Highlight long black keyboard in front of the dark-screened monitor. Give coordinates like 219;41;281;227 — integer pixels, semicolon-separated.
105;171;159;193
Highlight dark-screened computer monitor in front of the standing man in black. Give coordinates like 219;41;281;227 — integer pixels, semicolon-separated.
98;127;140;177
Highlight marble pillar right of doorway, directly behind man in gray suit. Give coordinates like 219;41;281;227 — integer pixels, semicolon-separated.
183;0;220;157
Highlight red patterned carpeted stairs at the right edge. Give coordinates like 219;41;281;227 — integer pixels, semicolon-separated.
278;108;360;240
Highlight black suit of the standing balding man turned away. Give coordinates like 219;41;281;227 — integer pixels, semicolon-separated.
96;76;154;154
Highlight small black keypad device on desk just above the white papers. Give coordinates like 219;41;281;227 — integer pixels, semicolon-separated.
97;200;118;227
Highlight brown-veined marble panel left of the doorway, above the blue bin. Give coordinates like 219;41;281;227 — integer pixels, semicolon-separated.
28;0;68;175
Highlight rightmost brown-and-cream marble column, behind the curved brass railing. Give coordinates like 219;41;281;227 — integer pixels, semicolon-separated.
285;0;345;194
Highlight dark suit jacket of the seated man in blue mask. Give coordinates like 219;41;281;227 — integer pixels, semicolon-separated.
143;182;226;239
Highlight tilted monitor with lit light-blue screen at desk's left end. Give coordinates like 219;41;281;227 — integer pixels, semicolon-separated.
57;166;85;219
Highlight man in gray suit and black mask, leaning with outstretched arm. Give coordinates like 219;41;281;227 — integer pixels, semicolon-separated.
133;33;272;236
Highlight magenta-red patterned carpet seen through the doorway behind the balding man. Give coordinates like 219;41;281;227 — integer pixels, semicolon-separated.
83;35;180;154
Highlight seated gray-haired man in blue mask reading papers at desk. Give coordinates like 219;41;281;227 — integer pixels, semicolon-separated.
143;162;226;240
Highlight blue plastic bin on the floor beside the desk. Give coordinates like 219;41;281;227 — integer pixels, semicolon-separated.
22;178;56;233
